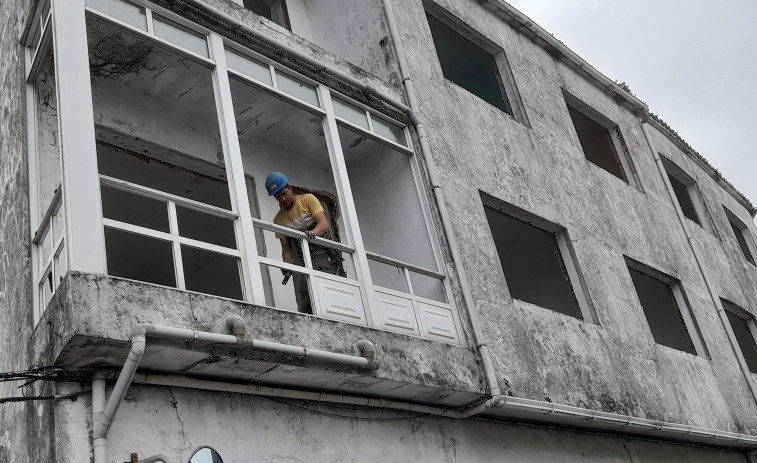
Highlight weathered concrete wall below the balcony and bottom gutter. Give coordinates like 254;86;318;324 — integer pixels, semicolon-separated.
50;386;745;463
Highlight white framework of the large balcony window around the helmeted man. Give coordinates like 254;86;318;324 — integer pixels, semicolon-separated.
29;0;462;344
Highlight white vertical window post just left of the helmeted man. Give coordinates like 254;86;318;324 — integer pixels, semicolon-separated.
208;33;266;305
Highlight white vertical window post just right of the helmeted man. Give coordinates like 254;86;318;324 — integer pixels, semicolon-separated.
318;85;379;325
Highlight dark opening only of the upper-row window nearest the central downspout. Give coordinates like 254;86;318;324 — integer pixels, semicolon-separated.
426;14;513;116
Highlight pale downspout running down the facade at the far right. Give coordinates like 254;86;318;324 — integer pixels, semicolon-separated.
641;121;757;402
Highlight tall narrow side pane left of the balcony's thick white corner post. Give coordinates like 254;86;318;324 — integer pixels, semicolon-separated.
34;41;61;220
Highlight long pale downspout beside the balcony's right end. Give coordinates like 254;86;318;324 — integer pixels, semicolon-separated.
382;0;502;402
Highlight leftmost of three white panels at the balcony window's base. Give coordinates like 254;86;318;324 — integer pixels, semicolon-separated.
313;277;367;325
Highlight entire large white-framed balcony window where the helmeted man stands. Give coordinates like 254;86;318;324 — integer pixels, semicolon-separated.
29;0;461;343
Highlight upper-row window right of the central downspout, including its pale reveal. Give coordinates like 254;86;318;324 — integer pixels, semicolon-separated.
426;4;523;119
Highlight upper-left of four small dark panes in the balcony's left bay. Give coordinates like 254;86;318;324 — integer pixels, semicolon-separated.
100;185;170;233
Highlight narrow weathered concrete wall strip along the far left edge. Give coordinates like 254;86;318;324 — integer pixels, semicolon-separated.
0;0;39;463
